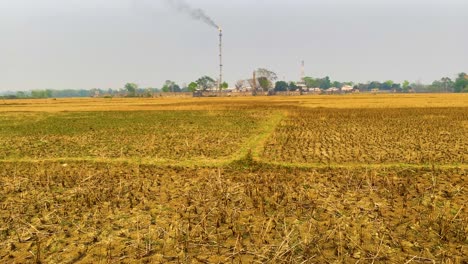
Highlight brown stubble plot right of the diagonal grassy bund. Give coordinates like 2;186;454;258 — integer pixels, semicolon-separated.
263;108;468;165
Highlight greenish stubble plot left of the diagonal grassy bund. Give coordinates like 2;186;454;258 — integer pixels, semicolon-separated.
0;110;271;162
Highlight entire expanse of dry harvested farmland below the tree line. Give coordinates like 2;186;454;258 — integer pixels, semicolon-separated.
0;94;468;263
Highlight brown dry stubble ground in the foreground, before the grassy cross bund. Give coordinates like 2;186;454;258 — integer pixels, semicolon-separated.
0;160;468;263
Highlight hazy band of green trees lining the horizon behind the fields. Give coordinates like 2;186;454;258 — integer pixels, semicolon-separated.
0;72;468;99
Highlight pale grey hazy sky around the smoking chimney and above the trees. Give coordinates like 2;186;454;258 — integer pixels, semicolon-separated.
0;0;468;91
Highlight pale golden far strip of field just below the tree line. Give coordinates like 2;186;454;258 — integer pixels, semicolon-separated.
0;94;468;113
